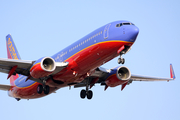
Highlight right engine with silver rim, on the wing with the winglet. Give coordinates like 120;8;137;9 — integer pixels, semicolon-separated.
105;66;131;87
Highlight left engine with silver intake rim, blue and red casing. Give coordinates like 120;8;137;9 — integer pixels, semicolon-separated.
30;57;56;78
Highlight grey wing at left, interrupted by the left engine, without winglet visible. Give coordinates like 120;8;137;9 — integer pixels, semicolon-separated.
0;58;68;83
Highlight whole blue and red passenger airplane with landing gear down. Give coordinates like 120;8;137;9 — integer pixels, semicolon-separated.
0;20;175;101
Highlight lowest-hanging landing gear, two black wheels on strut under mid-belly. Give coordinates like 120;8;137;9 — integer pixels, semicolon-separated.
80;78;93;100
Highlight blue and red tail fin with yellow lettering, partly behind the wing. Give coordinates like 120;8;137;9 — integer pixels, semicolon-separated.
6;34;21;85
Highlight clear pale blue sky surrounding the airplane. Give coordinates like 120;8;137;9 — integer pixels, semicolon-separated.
0;0;180;120
